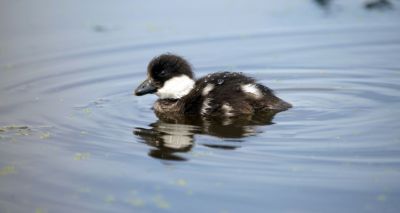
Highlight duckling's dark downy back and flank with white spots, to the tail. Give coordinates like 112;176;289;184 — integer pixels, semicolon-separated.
182;72;291;117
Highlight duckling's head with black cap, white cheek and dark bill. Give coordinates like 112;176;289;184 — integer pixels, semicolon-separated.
135;54;195;99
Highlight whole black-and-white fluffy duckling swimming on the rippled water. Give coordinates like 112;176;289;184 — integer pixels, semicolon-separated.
135;54;291;118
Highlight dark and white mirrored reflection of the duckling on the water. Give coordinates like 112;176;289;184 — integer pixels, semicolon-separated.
133;112;277;161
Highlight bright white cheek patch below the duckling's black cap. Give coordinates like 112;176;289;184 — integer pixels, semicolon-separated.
156;75;194;99
